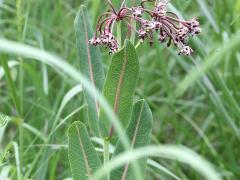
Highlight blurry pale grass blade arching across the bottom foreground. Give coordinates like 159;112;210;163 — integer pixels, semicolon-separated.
93;145;222;180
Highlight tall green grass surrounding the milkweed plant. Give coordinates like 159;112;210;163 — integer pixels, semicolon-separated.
0;0;240;180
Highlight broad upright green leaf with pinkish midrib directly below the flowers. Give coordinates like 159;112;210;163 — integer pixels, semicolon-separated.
99;41;139;137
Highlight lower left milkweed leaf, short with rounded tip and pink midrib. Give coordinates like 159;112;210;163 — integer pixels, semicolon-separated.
68;121;101;180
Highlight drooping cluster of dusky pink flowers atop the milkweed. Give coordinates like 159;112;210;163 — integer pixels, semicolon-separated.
89;0;201;56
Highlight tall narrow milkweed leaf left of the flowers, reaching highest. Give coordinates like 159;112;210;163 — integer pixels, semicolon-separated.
75;6;105;136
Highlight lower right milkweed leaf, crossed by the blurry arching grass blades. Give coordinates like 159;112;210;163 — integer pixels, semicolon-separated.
111;100;153;180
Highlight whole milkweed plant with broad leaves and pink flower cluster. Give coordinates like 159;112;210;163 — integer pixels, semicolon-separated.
68;0;201;180
